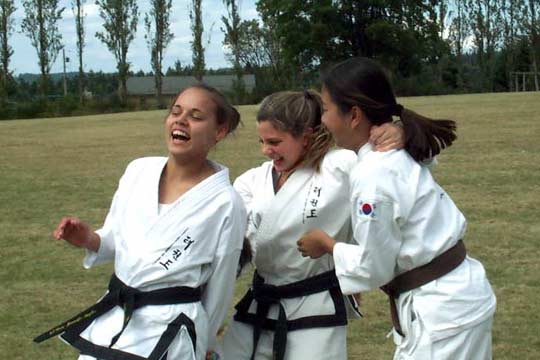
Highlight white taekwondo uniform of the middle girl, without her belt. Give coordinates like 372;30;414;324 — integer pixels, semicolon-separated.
222;150;356;360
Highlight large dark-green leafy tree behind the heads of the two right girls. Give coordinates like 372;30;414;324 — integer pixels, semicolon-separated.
257;0;447;83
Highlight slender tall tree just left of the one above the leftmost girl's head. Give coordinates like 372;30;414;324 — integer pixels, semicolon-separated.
144;0;173;103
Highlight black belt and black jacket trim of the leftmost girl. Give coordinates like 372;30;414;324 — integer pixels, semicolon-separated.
34;274;201;360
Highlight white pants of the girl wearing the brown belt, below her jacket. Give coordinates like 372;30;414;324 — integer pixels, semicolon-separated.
394;316;493;360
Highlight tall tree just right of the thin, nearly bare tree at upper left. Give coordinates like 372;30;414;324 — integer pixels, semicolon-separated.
96;0;139;103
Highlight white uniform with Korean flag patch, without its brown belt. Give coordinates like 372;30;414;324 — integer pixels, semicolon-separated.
333;144;496;359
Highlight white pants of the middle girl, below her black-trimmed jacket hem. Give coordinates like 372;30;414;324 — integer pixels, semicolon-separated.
220;321;347;360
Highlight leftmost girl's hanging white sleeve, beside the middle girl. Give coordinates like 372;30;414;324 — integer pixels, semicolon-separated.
201;199;246;351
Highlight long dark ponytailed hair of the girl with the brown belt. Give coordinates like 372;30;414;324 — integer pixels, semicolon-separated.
322;57;457;161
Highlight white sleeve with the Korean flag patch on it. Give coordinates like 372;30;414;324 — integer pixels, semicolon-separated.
334;168;405;294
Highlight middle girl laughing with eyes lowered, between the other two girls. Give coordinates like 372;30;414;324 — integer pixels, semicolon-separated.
222;91;403;360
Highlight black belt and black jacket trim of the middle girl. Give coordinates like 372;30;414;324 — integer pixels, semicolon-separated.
234;270;347;360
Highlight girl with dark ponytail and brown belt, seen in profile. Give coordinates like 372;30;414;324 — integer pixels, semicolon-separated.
297;58;496;360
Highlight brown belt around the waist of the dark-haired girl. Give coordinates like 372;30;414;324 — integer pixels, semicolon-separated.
381;240;467;336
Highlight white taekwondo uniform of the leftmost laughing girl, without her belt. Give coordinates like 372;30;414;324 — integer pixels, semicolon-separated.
73;157;247;360
